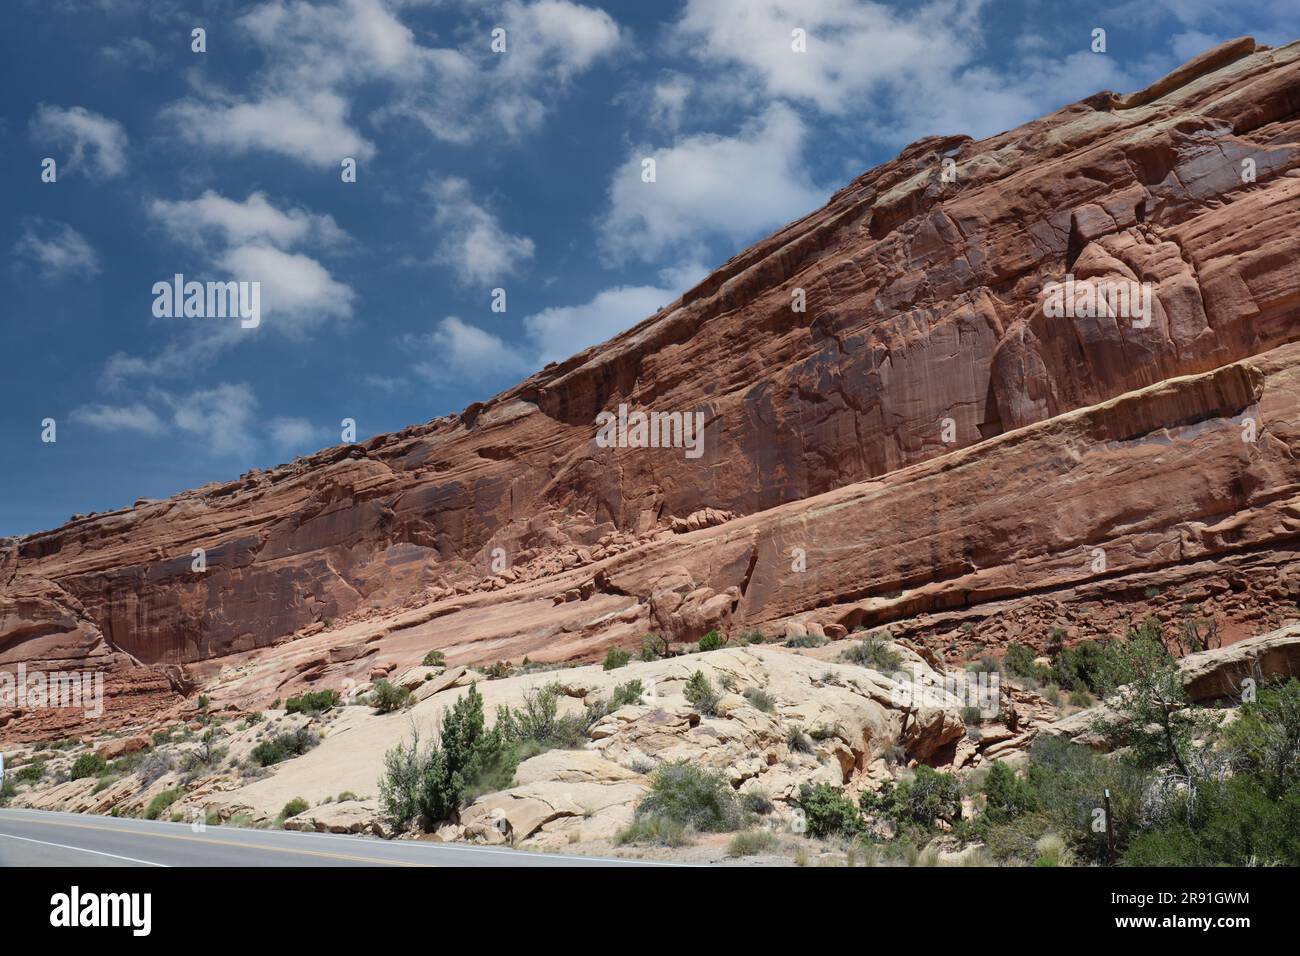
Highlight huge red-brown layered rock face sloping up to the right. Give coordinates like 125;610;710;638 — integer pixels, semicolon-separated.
0;39;1300;734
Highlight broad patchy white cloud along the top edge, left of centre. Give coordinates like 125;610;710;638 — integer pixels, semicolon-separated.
164;0;620;168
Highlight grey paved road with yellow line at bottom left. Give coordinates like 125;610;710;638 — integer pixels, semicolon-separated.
0;809;660;866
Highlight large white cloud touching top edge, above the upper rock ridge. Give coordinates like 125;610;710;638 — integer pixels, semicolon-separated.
672;0;1171;147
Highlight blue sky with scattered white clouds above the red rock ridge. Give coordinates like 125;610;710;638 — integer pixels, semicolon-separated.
0;0;1300;535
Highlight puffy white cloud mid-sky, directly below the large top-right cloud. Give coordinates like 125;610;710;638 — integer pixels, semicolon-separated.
602;104;828;261
